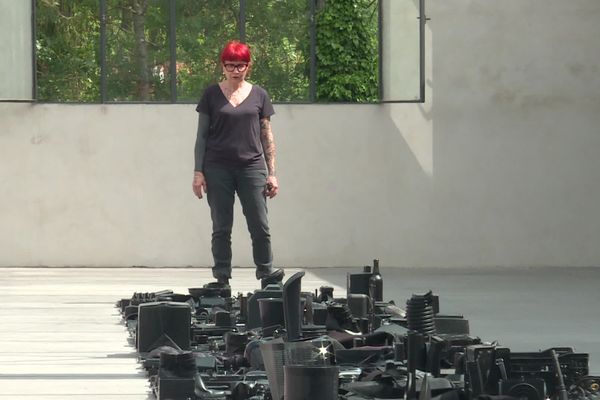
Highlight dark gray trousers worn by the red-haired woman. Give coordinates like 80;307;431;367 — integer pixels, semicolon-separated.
204;166;273;279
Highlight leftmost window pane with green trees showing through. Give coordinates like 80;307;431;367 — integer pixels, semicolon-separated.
36;0;100;102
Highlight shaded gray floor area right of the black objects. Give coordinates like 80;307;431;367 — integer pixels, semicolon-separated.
313;267;600;374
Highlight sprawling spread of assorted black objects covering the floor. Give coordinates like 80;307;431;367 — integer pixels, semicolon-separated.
117;260;600;400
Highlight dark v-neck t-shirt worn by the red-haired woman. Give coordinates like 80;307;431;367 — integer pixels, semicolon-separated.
196;84;275;169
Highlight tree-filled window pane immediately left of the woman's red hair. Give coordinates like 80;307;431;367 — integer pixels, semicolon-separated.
176;0;239;102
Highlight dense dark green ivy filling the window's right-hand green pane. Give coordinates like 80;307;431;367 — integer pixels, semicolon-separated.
317;0;378;102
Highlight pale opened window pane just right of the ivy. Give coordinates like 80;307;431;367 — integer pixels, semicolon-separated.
381;0;421;101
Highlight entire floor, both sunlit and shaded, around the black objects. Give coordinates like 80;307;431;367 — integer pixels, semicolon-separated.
0;268;600;400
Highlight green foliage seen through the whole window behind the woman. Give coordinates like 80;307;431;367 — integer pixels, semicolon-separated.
36;0;377;102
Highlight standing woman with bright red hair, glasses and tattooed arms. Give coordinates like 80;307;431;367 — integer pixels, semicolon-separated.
192;41;284;287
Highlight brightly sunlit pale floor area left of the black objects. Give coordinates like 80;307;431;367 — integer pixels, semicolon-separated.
0;268;342;400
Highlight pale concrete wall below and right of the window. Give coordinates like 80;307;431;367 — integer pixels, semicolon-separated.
0;0;600;266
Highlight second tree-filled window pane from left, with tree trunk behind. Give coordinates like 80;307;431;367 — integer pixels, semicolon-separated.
106;0;171;101
